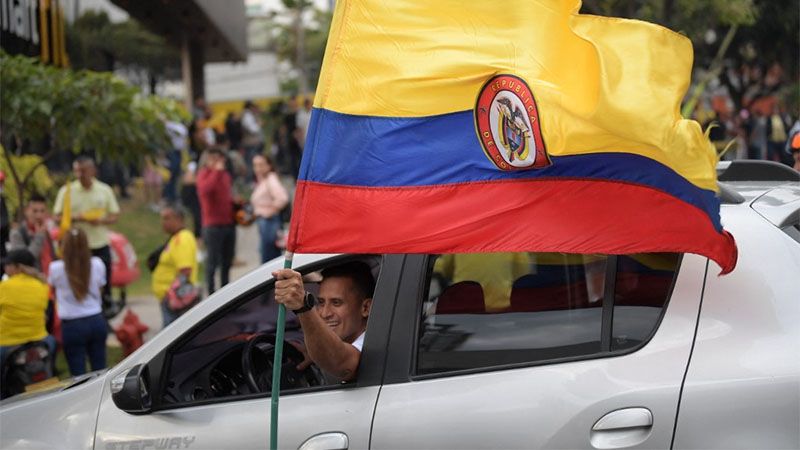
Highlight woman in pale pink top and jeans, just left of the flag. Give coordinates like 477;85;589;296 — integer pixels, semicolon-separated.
250;154;289;263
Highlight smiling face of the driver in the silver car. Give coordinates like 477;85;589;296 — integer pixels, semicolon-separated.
317;277;372;343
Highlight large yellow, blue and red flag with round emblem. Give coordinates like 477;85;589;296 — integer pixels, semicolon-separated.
288;0;736;272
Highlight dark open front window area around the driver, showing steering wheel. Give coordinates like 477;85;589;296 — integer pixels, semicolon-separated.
162;257;380;405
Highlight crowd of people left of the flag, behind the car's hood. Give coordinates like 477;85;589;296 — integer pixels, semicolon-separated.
0;99;311;384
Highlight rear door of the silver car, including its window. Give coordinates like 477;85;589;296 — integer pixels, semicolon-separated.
371;254;707;449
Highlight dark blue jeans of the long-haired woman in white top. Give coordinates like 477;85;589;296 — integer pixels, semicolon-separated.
61;314;108;376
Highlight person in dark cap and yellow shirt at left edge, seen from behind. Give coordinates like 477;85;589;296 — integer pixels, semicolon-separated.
0;248;56;370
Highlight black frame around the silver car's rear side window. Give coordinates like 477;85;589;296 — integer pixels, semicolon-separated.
384;253;684;384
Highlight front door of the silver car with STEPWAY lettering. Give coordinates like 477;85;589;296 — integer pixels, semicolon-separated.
95;256;403;450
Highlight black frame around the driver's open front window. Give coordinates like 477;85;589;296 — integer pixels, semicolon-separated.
147;254;404;412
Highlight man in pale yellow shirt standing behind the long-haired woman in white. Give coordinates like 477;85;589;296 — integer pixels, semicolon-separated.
53;156;119;304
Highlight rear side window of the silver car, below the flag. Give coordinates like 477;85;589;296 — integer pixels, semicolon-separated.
415;253;680;375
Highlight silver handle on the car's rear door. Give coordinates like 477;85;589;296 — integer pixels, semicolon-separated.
590;408;653;449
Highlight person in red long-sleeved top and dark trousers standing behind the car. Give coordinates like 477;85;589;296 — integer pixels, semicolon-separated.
197;147;236;295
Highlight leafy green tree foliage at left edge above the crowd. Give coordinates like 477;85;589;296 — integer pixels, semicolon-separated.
0;52;183;214
